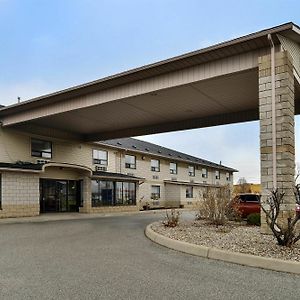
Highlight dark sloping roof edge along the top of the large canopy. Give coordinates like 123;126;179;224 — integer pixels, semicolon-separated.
0;22;300;115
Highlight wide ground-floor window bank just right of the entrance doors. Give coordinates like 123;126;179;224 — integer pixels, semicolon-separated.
92;180;136;207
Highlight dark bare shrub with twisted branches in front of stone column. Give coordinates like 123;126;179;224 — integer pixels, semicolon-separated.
261;189;300;247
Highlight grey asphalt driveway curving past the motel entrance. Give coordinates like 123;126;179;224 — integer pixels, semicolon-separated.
0;214;300;300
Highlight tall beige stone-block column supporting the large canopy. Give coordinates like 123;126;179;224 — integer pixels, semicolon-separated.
258;51;295;233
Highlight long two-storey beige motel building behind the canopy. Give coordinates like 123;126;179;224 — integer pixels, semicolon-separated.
0;128;236;218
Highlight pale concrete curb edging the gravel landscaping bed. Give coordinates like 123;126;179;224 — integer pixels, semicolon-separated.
145;224;300;274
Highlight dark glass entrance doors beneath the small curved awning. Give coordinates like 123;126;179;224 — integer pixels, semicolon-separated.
40;179;81;212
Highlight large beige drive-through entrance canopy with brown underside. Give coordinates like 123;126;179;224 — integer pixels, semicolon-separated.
0;23;300;141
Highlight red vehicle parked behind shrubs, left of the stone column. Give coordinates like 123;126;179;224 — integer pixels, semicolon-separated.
233;193;261;218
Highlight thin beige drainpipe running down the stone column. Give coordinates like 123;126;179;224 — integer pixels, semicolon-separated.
268;34;277;190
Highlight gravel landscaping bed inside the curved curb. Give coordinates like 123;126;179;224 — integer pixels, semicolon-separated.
151;220;300;262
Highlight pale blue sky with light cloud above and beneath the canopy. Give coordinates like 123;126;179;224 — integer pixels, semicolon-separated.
0;0;300;182
